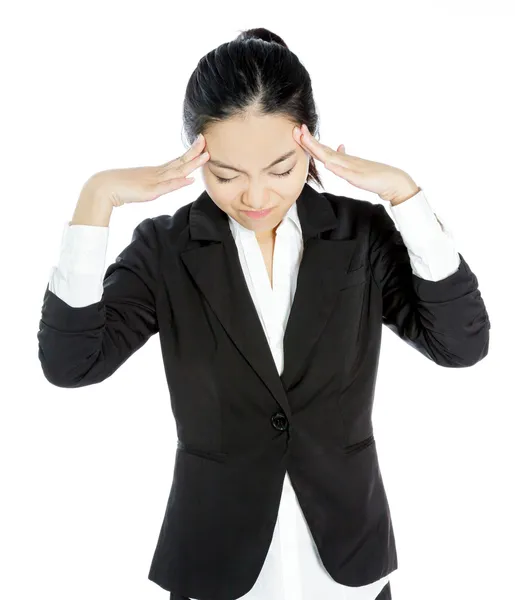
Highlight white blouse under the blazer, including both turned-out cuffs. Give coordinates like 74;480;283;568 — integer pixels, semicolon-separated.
49;190;460;600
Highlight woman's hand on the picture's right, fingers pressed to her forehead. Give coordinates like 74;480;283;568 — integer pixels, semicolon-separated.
293;125;420;205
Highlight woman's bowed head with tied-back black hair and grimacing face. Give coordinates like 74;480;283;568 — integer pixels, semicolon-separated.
183;29;323;238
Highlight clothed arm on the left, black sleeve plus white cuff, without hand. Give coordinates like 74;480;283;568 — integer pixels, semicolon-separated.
37;204;158;388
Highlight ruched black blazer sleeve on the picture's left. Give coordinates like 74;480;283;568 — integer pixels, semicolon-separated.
37;218;159;388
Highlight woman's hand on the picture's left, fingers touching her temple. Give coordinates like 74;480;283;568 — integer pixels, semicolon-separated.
89;134;209;206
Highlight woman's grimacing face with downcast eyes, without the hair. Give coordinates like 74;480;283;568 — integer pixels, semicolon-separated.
201;113;309;239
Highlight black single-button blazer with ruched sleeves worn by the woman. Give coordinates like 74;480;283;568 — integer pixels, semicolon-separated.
38;183;490;600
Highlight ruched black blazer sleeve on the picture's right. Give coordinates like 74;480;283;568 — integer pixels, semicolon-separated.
369;204;490;367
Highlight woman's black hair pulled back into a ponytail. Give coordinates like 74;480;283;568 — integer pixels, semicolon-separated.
183;27;324;188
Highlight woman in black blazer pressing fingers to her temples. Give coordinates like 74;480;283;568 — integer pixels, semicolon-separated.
38;29;490;600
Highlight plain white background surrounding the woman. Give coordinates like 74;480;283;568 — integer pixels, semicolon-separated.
0;0;515;600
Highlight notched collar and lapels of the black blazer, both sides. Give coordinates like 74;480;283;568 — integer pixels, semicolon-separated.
181;183;356;419
